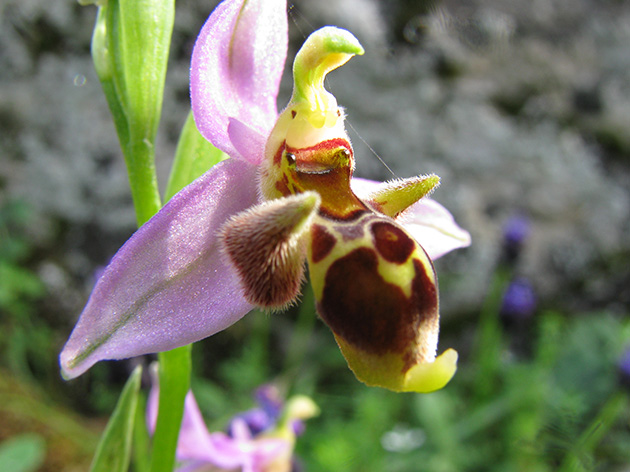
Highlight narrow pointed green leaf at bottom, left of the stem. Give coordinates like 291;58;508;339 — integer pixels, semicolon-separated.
90;366;142;472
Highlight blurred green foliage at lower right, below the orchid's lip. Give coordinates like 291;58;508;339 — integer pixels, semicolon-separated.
288;313;630;472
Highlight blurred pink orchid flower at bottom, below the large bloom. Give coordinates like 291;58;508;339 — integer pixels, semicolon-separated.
147;365;319;472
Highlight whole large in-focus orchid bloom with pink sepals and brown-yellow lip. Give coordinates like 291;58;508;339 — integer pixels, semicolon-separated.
60;0;470;392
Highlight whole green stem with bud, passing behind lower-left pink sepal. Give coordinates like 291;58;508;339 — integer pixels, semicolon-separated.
87;0;191;472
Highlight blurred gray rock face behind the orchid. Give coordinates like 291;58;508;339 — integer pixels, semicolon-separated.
0;0;630;318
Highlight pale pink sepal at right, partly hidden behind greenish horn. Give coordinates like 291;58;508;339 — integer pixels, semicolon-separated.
351;178;470;260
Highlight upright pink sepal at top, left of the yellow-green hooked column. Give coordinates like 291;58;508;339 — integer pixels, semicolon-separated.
190;0;288;164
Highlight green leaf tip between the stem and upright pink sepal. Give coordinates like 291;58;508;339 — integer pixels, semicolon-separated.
164;112;227;200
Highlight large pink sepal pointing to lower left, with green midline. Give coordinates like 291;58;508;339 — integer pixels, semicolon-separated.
60;159;258;378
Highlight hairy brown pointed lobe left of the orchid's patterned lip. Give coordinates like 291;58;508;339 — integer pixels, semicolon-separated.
220;192;321;309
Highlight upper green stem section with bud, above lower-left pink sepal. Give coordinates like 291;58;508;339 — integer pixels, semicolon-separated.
87;0;175;226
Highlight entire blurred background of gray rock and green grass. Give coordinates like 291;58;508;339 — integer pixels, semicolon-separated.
0;0;630;472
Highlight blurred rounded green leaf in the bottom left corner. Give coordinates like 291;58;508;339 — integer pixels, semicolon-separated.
0;433;46;472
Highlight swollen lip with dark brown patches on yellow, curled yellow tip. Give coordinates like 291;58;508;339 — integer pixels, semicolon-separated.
308;211;454;391
